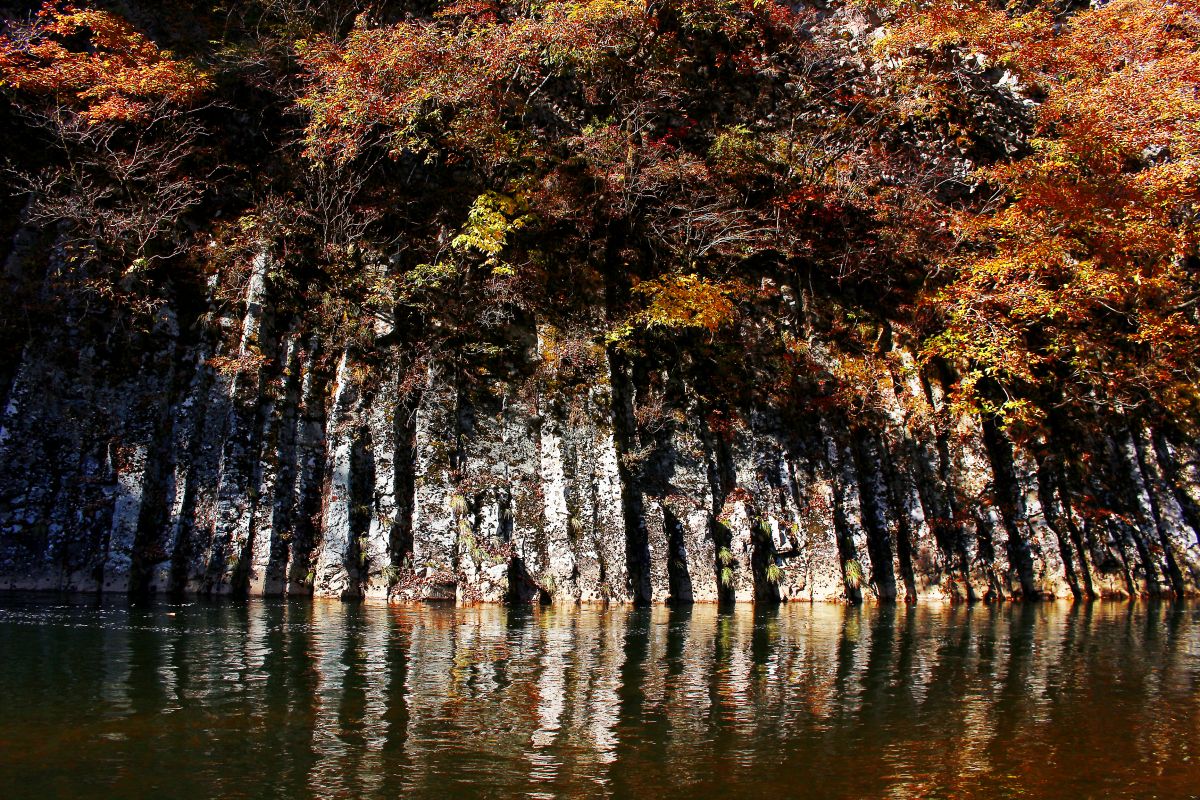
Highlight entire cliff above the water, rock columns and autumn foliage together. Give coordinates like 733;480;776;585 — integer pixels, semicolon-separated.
0;0;1200;603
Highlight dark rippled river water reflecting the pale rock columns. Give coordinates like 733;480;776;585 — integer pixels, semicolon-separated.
0;597;1200;800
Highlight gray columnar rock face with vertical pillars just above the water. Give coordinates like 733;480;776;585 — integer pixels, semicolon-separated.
0;248;1200;603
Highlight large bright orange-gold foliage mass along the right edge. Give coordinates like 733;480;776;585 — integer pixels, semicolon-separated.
888;0;1200;424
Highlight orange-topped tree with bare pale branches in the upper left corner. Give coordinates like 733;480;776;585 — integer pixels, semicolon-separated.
0;2;211;311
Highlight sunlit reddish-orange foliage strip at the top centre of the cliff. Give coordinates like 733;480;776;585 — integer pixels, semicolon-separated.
300;0;782;163
